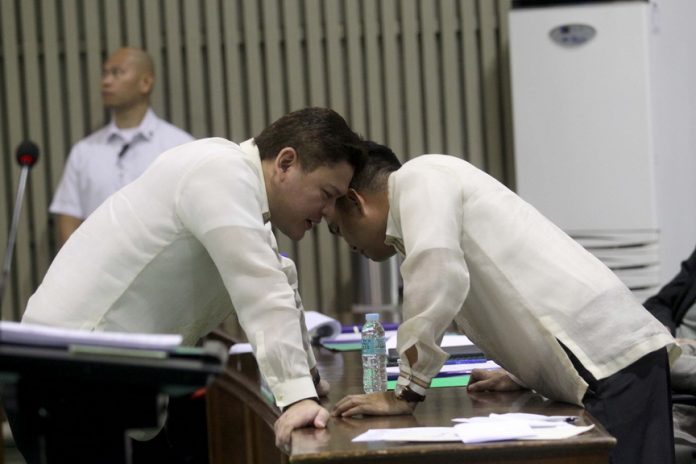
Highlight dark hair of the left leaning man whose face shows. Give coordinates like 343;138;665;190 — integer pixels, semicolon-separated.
254;107;365;172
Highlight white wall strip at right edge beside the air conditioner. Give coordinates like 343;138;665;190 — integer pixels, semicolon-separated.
651;0;696;282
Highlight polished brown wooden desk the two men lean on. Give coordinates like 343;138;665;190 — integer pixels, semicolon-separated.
208;349;615;464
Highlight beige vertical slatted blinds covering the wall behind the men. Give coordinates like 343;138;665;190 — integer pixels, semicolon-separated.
0;0;513;320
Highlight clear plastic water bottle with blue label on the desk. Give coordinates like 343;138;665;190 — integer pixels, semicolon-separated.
362;313;387;393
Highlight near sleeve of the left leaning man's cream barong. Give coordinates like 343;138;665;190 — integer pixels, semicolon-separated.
177;157;317;408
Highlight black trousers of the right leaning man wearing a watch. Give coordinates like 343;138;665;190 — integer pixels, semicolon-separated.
564;347;675;464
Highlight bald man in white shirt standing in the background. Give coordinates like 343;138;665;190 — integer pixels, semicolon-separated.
49;47;193;246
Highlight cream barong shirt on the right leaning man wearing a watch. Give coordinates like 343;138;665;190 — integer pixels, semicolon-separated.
386;155;679;405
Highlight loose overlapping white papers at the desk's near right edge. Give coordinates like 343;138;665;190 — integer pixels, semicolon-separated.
353;413;594;443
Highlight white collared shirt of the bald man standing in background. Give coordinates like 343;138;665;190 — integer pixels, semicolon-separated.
49;109;193;219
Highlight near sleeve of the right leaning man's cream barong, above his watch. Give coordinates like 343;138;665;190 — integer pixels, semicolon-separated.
390;170;469;395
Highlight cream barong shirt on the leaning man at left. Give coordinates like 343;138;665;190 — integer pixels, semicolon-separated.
23;138;317;407
